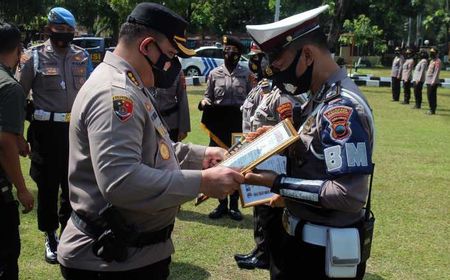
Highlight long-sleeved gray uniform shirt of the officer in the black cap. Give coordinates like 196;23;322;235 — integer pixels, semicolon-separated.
58;52;205;271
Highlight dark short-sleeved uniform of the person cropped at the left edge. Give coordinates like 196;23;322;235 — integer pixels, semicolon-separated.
0;64;25;279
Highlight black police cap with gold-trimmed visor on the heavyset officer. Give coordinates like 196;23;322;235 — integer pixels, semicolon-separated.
127;2;195;57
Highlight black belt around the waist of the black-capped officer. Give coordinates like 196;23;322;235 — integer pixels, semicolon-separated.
71;211;173;247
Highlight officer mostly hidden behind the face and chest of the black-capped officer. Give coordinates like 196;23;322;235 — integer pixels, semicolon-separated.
156;70;191;142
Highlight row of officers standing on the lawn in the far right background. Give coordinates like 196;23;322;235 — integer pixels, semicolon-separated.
391;47;442;115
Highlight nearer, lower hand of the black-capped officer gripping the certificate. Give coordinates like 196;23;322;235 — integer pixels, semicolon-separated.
200;166;244;199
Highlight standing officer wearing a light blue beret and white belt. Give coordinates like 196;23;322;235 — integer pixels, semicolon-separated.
18;7;92;264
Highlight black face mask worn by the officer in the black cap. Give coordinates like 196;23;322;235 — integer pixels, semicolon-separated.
142;43;181;88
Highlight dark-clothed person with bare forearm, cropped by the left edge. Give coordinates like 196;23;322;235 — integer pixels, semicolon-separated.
0;23;34;280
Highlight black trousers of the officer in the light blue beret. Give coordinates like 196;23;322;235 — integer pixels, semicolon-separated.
28;121;72;232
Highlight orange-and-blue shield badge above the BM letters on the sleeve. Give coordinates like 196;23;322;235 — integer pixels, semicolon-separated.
323;106;353;141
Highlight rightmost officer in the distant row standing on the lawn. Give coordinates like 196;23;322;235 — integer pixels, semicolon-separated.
425;48;442;115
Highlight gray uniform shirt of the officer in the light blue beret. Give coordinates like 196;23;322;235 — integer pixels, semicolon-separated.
18;40;92;113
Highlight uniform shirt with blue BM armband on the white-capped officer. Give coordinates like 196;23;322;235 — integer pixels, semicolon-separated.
272;69;374;226
